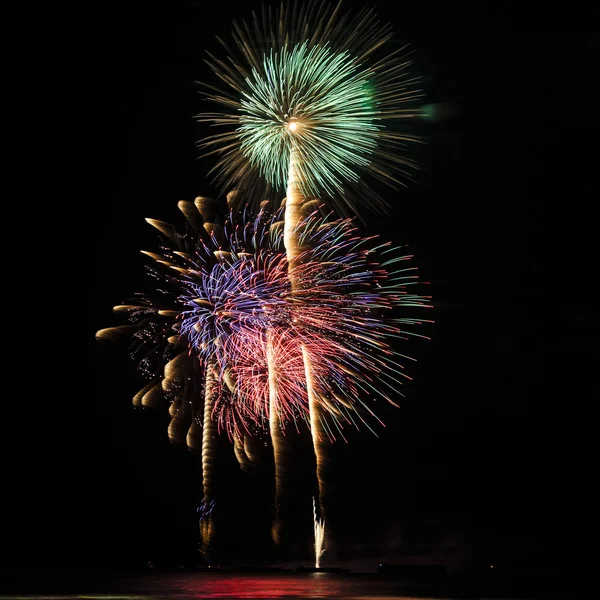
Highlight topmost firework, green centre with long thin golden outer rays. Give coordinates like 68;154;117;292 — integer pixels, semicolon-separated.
198;0;422;212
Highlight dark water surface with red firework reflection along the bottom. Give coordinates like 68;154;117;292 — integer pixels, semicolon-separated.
0;571;574;600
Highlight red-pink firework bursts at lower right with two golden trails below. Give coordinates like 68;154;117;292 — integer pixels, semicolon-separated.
216;211;429;541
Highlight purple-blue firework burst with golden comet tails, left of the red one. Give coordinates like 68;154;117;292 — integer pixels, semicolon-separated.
97;198;304;550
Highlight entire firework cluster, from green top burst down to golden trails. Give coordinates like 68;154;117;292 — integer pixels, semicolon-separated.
97;2;429;558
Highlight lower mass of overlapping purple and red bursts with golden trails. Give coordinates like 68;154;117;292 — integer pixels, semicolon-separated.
97;200;428;544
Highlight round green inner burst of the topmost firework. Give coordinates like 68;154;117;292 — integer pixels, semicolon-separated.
237;42;381;196
